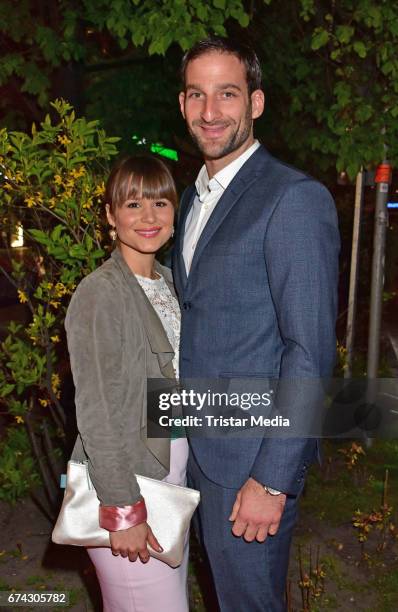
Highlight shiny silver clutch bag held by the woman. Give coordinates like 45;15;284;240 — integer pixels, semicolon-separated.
52;461;200;567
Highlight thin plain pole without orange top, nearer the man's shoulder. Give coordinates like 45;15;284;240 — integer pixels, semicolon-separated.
344;168;365;378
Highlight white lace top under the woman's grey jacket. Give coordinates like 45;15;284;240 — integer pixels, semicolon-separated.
135;274;181;379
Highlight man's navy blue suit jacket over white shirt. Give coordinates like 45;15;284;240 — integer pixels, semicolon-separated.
173;146;340;495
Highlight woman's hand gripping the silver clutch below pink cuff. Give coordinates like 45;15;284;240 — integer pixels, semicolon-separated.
109;523;163;563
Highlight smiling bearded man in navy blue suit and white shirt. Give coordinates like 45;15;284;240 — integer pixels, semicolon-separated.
173;37;339;612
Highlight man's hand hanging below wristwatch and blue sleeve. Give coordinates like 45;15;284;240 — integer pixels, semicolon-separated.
229;478;286;542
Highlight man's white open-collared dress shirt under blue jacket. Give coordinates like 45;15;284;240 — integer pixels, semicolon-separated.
182;140;260;275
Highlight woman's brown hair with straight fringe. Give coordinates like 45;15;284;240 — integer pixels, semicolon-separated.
104;155;178;214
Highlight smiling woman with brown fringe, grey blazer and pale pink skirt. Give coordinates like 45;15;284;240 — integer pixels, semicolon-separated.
65;157;188;612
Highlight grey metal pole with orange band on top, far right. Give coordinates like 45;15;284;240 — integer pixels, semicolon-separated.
367;162;391;379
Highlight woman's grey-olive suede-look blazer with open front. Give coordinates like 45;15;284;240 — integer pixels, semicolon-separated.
65;248;174;506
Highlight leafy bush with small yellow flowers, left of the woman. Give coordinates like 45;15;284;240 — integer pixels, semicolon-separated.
0;100;118;500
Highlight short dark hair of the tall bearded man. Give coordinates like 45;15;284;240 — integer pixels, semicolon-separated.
181;36;262;95
